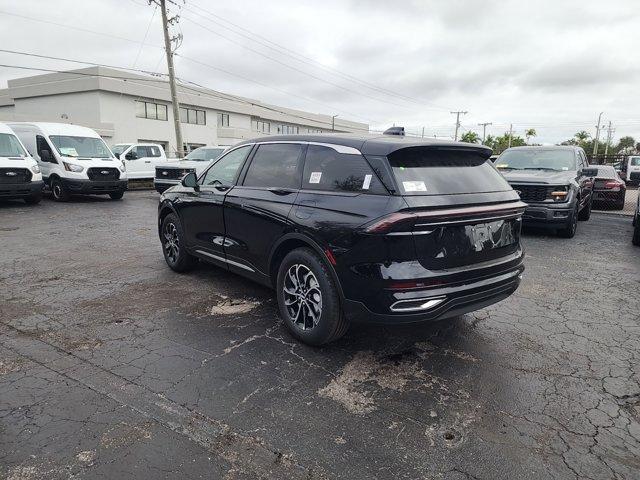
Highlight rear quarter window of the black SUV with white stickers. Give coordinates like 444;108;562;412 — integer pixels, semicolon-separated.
302;145;387;195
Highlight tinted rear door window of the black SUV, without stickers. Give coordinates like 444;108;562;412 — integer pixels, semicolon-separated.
243;143;302;188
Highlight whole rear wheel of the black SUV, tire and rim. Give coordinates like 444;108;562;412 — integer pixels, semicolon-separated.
276;248;349;346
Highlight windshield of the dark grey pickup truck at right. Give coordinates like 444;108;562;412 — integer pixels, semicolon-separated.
496;149;576;171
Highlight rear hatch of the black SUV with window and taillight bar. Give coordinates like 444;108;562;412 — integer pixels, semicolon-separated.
368;147;525;270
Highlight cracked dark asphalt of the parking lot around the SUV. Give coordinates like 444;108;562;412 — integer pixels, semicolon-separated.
0;191;640;480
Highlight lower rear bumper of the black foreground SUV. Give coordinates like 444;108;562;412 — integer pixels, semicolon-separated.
344;263;524;324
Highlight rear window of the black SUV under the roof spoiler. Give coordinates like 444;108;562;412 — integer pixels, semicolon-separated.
388;147;511;195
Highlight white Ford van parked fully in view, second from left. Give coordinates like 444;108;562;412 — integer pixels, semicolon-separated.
9;123;127;201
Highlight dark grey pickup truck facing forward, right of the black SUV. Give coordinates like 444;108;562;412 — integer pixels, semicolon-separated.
495;146;598;238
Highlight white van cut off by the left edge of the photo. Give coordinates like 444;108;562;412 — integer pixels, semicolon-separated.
0;123;44;204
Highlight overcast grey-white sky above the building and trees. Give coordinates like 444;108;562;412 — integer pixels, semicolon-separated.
0;0;640;143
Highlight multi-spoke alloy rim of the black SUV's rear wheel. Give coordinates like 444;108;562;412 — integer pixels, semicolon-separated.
282;263;322;330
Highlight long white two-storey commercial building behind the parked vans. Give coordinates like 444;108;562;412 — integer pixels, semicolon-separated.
0;67;369;154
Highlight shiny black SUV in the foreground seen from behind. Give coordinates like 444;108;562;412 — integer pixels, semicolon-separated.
158;135;525;345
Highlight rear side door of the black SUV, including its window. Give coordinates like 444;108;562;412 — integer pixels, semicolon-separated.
224;142;306;283
